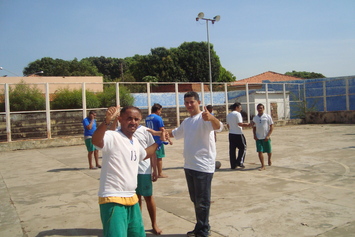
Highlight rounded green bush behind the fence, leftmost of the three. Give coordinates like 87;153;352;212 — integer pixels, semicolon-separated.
0;81;46;111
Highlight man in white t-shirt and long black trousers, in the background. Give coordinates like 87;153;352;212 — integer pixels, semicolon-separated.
226;102;250;169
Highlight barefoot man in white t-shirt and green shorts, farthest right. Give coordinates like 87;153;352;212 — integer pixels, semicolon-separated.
253;104;274;171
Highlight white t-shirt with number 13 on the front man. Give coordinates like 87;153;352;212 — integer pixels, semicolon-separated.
98;131;147;197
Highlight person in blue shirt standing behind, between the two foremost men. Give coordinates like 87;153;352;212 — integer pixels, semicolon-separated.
145;103;171;178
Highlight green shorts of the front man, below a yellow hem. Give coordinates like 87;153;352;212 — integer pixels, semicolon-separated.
100;203;146;237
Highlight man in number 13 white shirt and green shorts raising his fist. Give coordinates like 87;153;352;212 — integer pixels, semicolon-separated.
92;106;165;237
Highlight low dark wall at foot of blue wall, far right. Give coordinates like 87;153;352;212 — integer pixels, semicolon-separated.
305;110;355;124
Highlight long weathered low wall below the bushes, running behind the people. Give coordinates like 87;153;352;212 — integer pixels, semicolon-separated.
0;106;303;151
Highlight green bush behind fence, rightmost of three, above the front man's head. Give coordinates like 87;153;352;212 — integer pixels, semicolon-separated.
97;85;134;107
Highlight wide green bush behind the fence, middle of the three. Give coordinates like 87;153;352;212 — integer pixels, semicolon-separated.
51;88;100;109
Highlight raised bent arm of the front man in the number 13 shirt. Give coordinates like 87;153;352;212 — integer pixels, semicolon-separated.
92;106;120;148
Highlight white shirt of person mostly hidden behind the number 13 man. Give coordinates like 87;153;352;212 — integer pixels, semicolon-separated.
133;126;155;174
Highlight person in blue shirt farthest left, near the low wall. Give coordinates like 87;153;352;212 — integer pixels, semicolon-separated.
83;110;101;169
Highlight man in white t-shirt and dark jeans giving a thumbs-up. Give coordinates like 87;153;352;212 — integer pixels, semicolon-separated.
169;92;223;236
